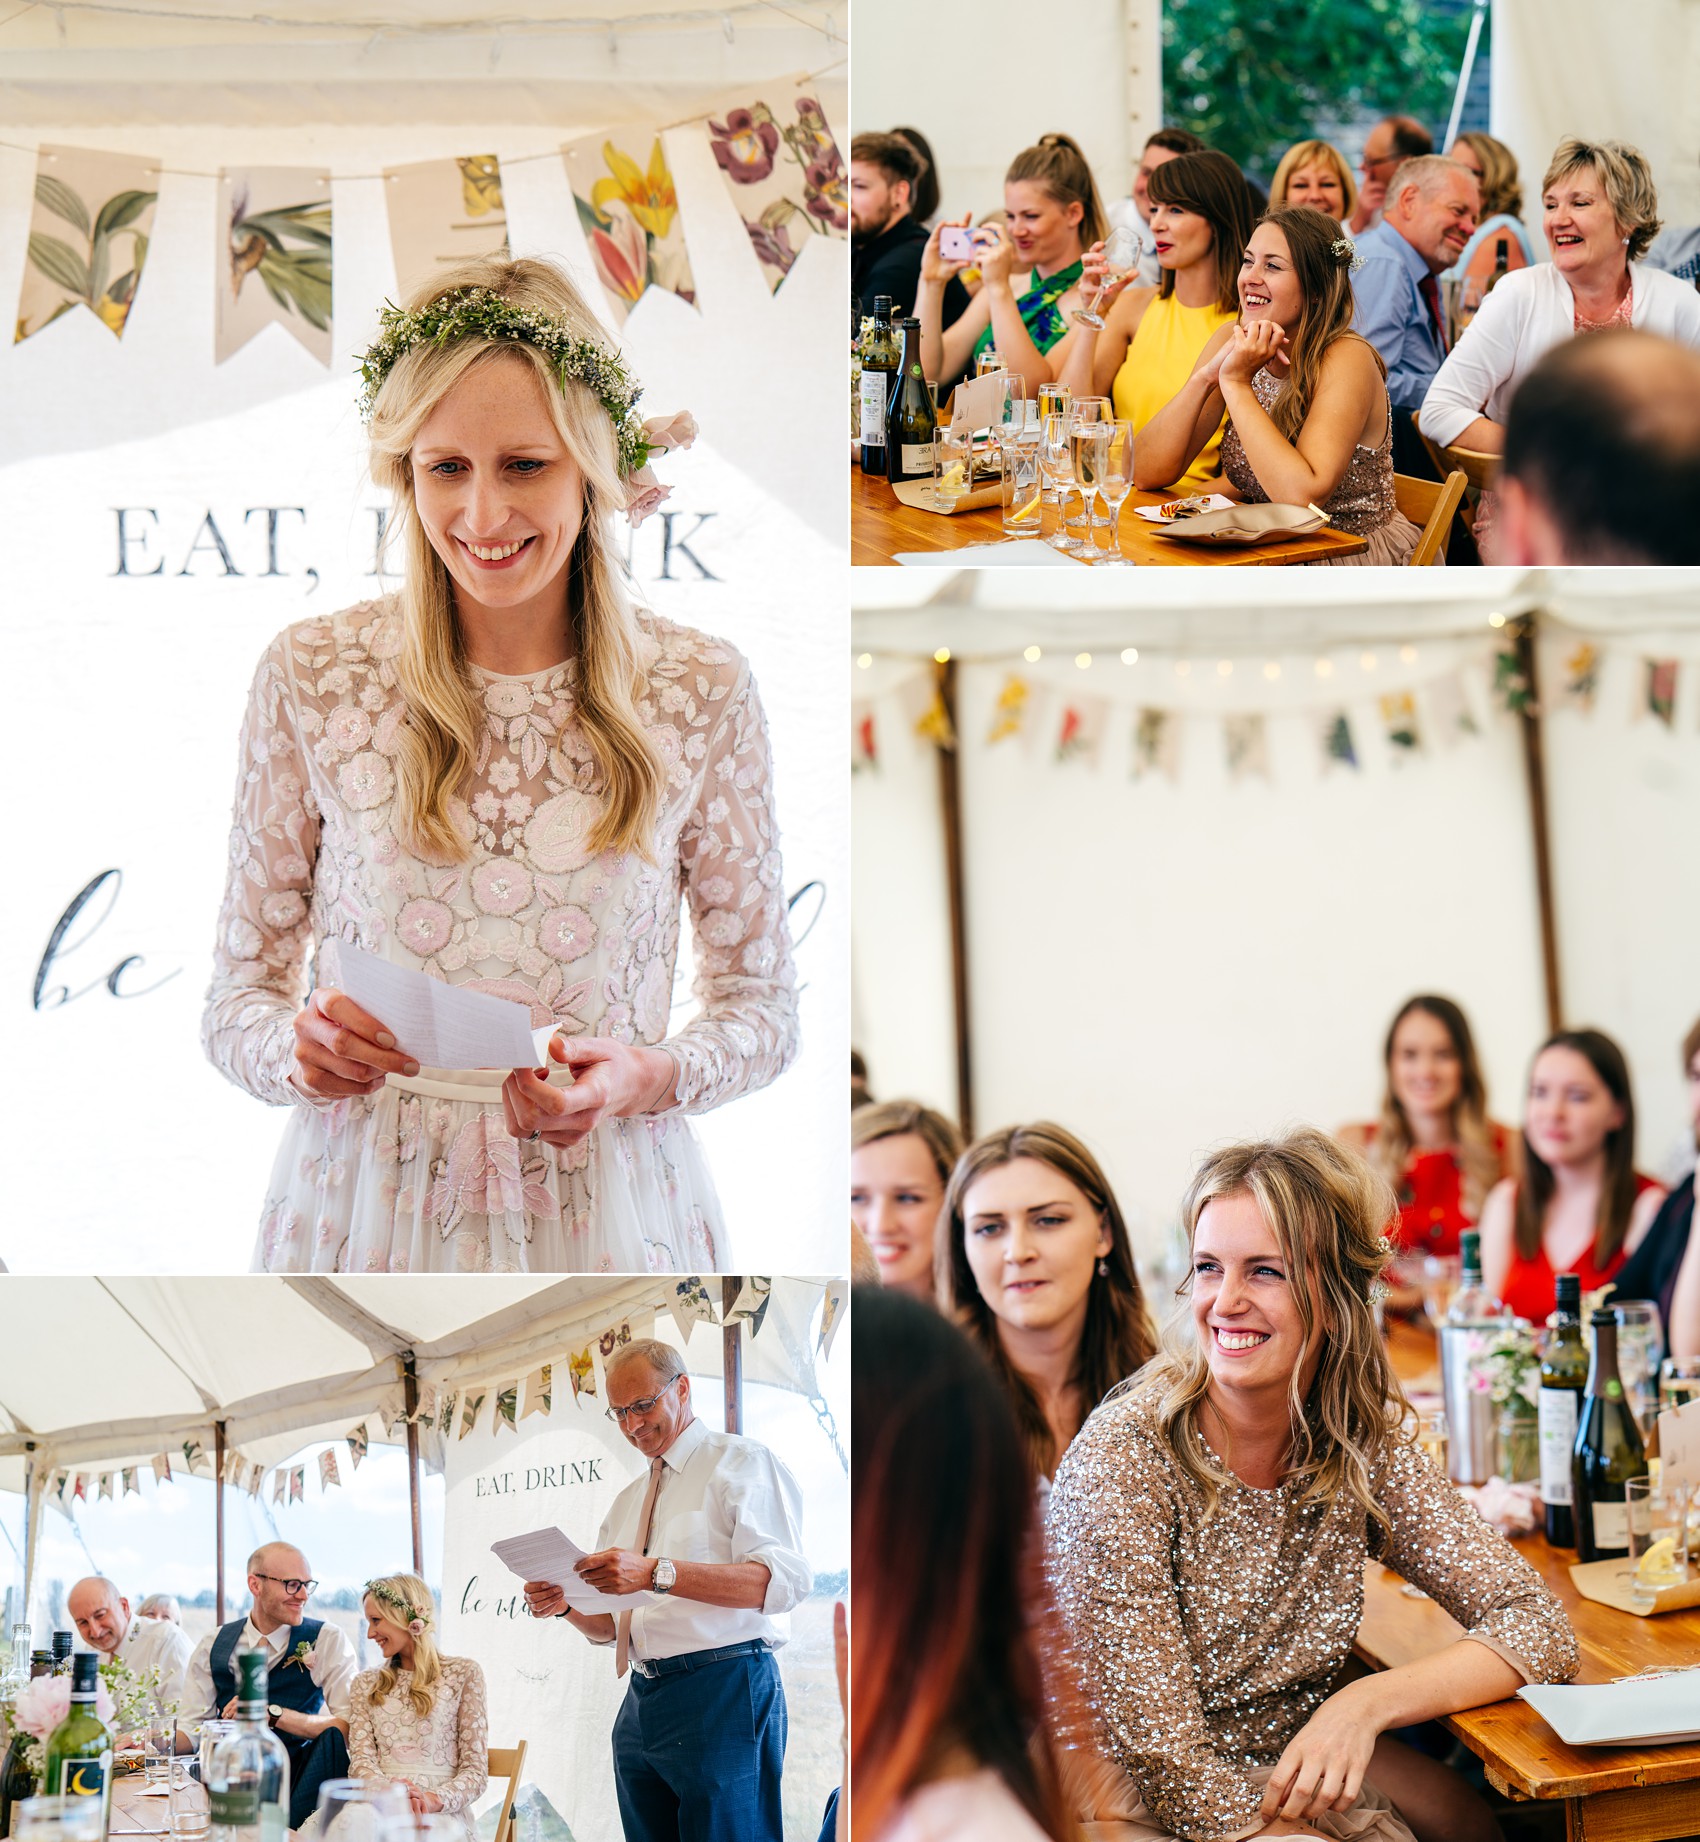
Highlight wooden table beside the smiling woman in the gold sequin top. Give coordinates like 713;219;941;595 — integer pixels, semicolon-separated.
1356;1324;1700;1842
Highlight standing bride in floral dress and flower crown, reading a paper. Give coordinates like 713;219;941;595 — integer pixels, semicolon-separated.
203;260;796;1273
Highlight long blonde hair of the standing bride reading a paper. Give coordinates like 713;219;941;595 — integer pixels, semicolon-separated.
370;256;663;864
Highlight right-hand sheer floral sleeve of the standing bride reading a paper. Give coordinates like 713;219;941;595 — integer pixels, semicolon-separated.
665;667;798;1113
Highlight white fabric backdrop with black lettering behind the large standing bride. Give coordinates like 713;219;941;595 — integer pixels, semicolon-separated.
0;82;847;1271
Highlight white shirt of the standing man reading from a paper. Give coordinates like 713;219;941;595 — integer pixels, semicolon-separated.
597;1420;814;1661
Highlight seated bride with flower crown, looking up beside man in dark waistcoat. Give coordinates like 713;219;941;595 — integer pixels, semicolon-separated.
298;1573;490;1842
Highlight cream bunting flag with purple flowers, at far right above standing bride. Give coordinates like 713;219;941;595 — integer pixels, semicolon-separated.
707;90;849;293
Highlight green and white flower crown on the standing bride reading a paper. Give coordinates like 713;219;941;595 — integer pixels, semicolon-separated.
359;287;696;525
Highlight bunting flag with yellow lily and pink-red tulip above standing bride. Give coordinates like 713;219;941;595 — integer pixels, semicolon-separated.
562;127;696;326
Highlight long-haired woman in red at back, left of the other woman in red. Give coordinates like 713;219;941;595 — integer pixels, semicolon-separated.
1339;993;1516;1262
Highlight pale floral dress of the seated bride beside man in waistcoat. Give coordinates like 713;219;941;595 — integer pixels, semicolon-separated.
337;1656;490;1842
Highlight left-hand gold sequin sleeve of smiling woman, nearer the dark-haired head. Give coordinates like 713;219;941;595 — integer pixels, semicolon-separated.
1046;1398;1262;1842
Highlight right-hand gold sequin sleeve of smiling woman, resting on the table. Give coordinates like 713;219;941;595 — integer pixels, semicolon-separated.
1368;1444;1580;1682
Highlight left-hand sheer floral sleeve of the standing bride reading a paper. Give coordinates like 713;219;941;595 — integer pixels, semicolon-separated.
201;634;333;1107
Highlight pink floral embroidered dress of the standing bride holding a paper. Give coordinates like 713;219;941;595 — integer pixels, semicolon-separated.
203;600;798;1273
